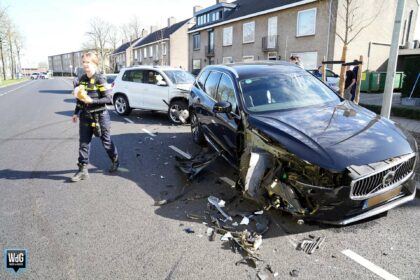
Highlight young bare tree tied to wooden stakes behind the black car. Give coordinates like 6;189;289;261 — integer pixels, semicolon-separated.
333;0;385;96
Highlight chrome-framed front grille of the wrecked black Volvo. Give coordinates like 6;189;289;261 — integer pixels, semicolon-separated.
349;154;416;200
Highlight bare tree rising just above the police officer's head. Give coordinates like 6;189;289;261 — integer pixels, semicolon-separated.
86;18;111;72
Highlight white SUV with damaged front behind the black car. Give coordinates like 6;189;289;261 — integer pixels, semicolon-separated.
112;66;195;123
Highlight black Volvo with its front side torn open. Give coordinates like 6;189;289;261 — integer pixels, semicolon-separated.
189;62;417;225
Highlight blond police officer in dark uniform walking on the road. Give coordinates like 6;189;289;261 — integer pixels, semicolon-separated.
71;52;119;182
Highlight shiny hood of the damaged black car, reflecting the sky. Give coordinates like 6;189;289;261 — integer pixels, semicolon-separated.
248;101;416;171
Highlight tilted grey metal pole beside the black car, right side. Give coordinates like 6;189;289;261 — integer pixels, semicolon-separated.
381;0;405;119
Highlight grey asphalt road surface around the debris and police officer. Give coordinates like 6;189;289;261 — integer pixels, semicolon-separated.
0;79;420;279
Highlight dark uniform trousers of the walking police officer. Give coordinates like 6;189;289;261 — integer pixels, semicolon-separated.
79;110;118;164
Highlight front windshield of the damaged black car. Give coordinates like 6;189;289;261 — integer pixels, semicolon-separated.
239;73;340;112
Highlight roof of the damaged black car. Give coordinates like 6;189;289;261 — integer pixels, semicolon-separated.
205;61;306;80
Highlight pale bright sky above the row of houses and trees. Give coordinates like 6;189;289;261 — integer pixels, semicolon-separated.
0;0;420;67
